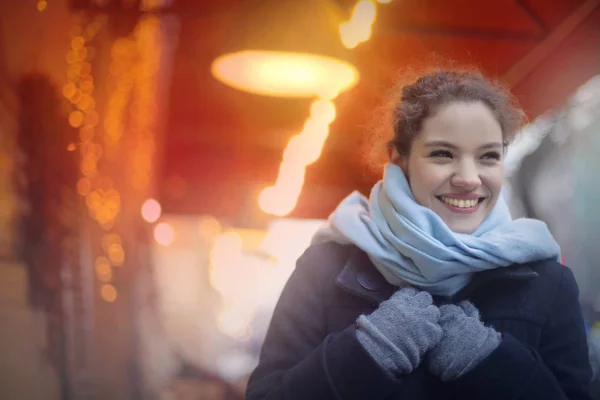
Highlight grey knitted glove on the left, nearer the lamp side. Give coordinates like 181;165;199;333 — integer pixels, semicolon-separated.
356;288;442;376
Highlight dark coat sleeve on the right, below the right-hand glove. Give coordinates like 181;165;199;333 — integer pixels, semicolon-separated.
455;267;593;400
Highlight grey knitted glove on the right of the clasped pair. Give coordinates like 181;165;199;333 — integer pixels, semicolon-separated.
428;300;502;382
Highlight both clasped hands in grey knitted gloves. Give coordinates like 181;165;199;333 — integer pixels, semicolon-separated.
357;287;501;382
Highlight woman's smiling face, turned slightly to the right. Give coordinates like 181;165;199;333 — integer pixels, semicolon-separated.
398;101;504;233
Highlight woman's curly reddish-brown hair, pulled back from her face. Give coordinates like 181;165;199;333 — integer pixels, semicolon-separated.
369;68;525;172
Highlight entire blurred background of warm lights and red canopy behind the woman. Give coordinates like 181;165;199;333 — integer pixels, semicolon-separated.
0;0;600;400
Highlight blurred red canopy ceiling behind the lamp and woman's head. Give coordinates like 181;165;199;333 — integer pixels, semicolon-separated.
161;0;600;225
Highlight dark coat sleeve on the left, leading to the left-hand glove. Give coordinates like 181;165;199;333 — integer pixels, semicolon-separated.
246;245;398;400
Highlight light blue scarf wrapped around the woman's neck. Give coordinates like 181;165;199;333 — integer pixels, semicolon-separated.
313;164;560;296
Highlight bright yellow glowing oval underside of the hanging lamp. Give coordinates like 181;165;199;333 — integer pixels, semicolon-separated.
212;50;359;98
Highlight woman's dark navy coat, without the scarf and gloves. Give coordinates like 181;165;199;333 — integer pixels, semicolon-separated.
246;243;592;400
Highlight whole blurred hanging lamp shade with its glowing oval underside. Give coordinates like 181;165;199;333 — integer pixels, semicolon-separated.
211;0;359;98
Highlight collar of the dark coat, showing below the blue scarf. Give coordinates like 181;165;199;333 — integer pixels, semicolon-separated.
335;247;538;305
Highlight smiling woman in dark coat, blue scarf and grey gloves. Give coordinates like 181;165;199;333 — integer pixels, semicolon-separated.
247;71;591;400
